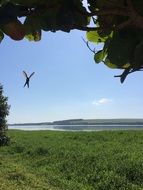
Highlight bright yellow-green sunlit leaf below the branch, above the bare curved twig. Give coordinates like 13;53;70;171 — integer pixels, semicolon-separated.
86;31;108;43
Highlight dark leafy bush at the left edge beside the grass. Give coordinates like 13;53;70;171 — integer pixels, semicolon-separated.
0;84;9;146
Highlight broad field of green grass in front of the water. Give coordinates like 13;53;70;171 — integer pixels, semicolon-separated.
0;130;143;190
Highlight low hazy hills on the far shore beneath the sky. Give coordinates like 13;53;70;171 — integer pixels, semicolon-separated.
9;119;143;126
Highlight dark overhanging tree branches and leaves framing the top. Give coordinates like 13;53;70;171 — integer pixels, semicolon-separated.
0;0;143;82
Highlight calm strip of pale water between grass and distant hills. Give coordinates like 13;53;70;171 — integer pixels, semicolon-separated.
8;124;143;131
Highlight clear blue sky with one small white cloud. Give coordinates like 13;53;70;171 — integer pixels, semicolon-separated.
0;31;143;123
